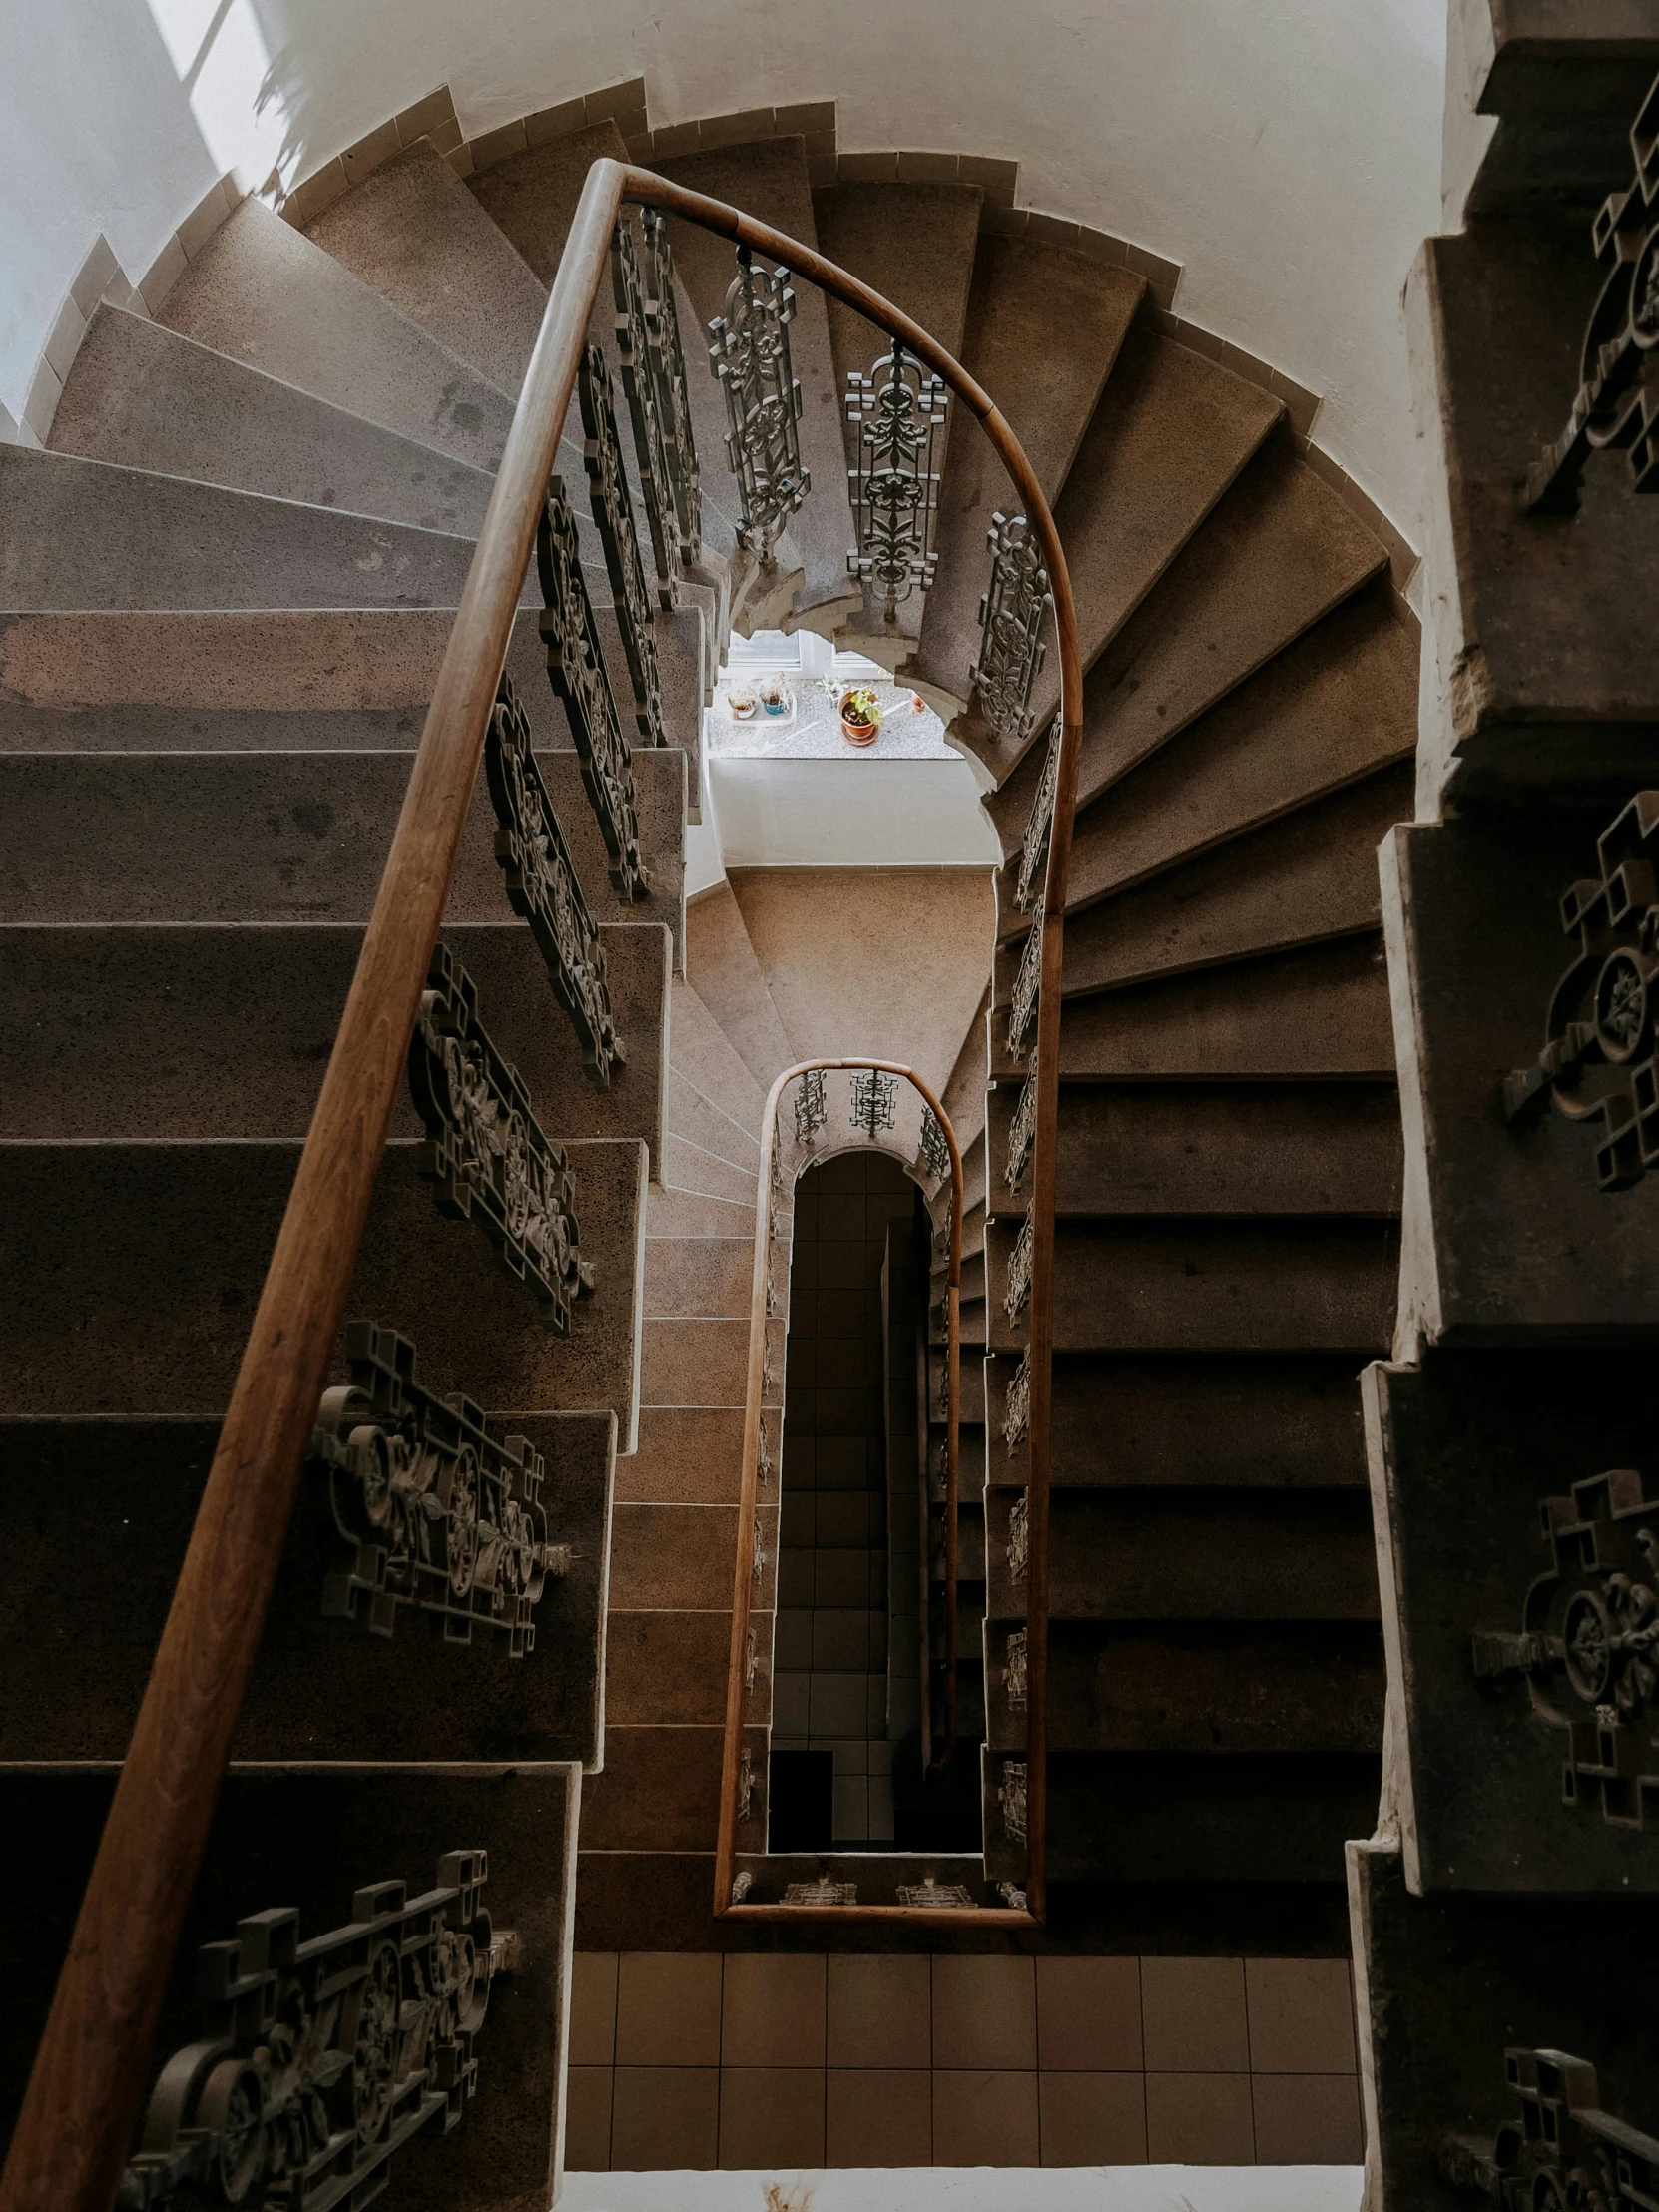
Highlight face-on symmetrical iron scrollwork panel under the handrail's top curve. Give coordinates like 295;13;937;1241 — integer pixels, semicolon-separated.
847;342;951;624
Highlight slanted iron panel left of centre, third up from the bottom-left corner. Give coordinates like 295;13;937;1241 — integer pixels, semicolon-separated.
409;944;593;1336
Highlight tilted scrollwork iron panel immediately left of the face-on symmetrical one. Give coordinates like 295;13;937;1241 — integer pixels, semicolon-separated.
708;246;812;562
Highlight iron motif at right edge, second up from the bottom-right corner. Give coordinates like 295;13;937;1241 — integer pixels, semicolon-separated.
1473;1466;1659;1827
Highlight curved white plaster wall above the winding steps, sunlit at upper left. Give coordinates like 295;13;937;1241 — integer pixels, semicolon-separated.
0;0;1444;542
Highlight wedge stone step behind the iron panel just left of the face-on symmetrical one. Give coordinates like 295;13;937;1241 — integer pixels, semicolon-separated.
657;137;862;635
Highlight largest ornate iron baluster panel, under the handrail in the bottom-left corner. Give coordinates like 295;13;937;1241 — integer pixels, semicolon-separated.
117;1852;518;2212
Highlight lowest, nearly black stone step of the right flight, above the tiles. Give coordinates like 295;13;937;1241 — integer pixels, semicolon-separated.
984;1752;1381;1894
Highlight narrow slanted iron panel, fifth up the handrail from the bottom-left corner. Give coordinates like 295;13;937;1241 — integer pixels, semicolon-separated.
535;475;651;904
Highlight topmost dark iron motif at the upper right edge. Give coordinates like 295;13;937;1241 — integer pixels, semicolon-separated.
1522;80;1659;515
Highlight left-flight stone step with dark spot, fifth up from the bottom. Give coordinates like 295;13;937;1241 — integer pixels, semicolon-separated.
0;750;686;955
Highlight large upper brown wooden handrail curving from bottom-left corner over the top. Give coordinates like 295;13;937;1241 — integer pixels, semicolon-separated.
0;160;1082;2212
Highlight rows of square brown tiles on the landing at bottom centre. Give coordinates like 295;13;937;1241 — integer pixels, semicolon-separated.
566;1951;1361;2172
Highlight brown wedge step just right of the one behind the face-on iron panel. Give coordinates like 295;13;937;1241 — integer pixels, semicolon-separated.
909;233;1146;699
